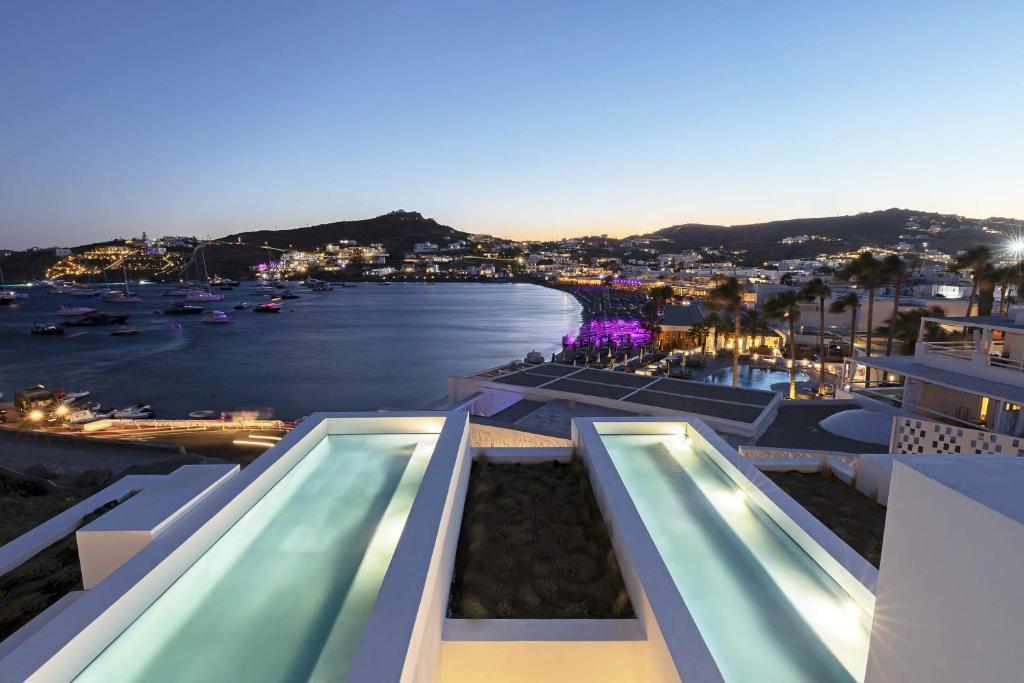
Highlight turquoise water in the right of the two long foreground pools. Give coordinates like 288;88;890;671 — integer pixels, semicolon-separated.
601;435;871;683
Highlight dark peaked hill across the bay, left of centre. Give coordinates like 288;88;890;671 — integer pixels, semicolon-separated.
221;211;471;255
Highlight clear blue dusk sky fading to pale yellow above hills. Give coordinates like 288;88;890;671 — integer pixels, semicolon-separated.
0;0;1024;248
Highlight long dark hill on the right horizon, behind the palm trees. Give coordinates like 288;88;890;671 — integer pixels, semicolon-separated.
637;209;999;263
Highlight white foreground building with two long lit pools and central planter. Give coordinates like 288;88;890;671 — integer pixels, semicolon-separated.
0;411;1024;683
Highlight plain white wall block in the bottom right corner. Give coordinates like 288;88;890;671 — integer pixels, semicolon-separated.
865;456;1024;683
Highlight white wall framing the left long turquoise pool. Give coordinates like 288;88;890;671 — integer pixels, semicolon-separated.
0;412;469;683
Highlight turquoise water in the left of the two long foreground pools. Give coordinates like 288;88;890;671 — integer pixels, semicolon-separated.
76;434;437;683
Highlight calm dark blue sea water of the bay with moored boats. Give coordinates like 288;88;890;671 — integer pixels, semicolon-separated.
0;283;581;418
